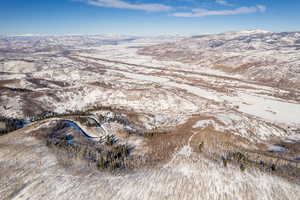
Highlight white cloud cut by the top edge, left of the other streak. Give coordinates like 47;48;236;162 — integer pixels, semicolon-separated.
77;0;172;12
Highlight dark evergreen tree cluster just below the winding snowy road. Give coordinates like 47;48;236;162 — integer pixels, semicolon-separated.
46;122;132;171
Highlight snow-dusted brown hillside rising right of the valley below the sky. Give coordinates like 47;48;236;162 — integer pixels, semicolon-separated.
139;30;300;89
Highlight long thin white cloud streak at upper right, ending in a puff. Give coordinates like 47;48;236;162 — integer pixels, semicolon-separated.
172;5;267;17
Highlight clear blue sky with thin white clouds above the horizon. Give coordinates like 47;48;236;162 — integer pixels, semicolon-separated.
0;0;300;35
